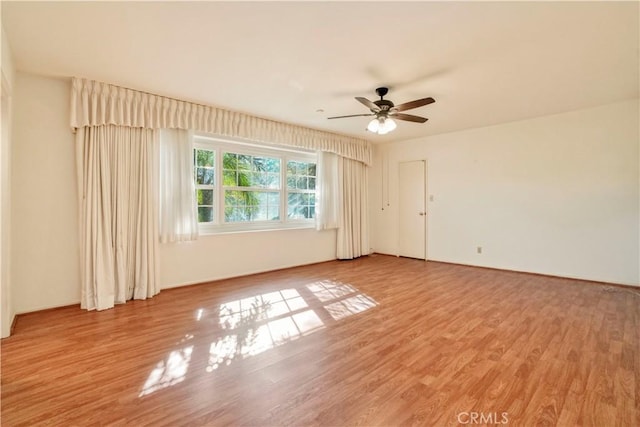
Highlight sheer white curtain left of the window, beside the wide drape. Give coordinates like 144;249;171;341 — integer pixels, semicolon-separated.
158;129;198;243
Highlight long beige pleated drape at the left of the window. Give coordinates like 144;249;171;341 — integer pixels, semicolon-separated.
76;125;159;310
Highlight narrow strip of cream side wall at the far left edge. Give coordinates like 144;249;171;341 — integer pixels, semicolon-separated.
0;23;15;338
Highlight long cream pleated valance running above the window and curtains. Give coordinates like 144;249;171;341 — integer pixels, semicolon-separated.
71;78;372;166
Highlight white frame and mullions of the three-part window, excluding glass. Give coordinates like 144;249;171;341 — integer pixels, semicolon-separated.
192;133;319;234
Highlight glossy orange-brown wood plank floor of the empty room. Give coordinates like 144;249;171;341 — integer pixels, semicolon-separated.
1;255;640;427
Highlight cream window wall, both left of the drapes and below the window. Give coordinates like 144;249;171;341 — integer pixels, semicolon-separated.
12;72;336;313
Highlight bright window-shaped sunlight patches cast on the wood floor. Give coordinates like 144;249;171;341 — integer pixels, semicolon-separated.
139;280;378;397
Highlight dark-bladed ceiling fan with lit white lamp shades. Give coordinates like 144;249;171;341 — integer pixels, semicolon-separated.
329;87;436;135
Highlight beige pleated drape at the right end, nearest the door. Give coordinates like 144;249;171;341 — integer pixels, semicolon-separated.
337;157;370;259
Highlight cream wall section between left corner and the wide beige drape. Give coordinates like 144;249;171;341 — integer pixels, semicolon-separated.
11;72;80;313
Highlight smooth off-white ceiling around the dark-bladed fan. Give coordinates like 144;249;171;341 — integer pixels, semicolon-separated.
2;1;640;142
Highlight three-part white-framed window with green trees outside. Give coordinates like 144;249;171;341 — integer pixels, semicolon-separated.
194;136;316;232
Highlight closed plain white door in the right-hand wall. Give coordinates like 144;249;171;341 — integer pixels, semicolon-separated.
399;160;427;259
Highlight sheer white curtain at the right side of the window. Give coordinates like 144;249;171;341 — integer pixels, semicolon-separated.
316;151;340;230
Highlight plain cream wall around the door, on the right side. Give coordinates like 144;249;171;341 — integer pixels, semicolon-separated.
371;99;640;285
